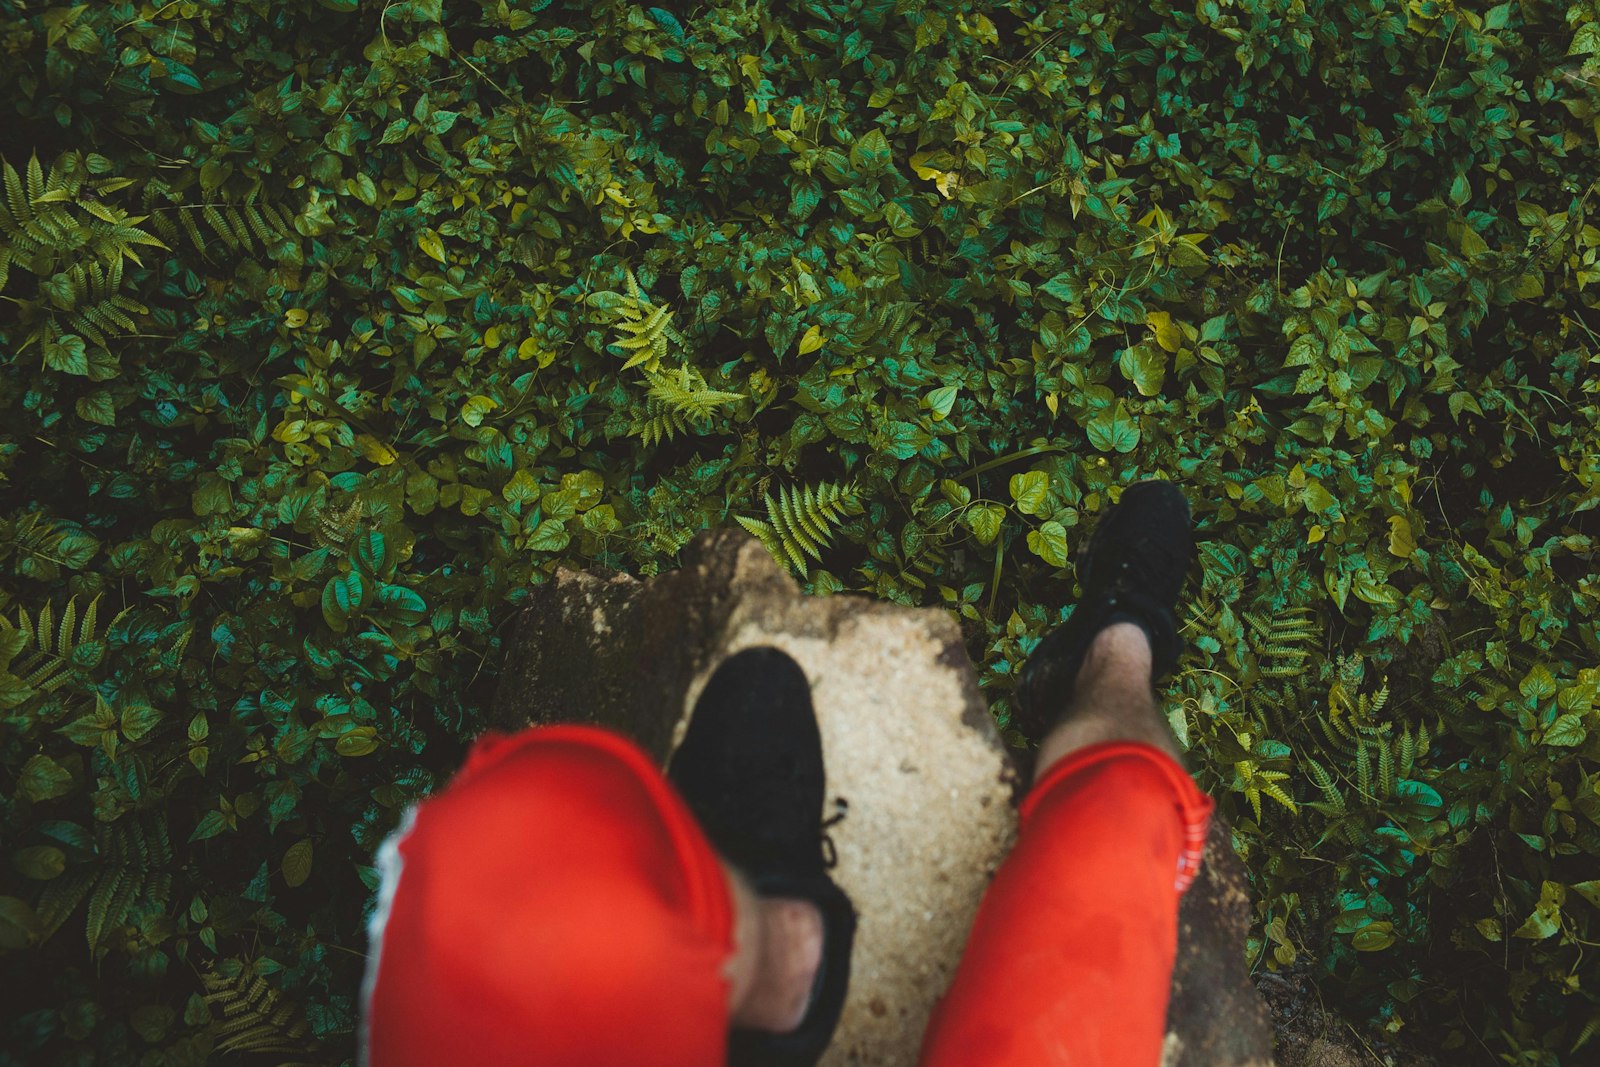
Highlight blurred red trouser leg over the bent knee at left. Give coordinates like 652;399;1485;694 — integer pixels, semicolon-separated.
366;726;733;1067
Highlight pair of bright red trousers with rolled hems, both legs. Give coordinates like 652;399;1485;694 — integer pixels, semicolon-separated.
362;726;1213;1067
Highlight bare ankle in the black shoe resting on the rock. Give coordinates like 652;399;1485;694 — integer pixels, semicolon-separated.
723;862;822;1032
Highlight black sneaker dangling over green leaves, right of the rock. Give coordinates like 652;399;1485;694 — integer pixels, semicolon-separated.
1016;480;1194;739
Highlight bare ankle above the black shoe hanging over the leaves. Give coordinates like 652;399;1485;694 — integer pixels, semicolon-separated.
1034;622;1184;782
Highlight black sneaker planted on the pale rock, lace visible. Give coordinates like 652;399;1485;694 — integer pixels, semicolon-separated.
667;648;856;1067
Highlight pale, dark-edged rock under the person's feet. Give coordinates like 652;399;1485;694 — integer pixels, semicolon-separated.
494;531;1272;1067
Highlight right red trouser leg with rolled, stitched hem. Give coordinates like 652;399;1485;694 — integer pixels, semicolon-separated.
920;741;1214;1067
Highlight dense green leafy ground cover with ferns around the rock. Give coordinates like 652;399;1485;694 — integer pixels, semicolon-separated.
0;0;1600;1065
